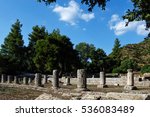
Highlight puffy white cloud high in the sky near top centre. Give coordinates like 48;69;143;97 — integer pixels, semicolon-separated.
53;0;95;25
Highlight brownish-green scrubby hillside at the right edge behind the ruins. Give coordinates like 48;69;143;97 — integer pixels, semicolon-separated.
121;38;150;67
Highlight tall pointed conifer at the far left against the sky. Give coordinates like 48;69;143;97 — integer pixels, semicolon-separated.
0;19;24;73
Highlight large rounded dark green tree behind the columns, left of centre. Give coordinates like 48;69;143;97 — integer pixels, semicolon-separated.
34;30;79;75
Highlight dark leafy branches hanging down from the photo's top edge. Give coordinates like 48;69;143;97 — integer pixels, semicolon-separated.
37;0;150;28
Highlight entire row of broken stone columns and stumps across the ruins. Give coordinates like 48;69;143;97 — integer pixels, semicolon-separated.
1;69;137;91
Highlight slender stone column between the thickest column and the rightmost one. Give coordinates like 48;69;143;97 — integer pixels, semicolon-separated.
97;71;107;88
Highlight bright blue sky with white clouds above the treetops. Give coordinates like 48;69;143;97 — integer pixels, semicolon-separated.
0;0;148;54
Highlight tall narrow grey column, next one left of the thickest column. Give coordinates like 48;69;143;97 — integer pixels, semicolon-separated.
52;70;59;89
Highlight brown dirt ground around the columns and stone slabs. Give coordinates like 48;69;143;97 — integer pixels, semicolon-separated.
0;83;150;100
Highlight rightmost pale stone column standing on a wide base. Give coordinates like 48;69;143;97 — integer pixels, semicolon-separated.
124;69;137;90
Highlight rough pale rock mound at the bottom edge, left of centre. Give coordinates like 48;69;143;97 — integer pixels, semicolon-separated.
35;93;61;100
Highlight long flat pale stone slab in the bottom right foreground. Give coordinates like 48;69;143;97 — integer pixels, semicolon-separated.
106;92;150;100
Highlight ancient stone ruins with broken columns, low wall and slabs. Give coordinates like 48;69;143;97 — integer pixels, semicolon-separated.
0;69;150;100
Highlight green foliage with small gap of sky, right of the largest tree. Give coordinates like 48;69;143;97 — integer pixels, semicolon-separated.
75;42;106;73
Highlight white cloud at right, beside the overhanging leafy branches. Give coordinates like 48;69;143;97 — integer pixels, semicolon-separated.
109;14;150;36
